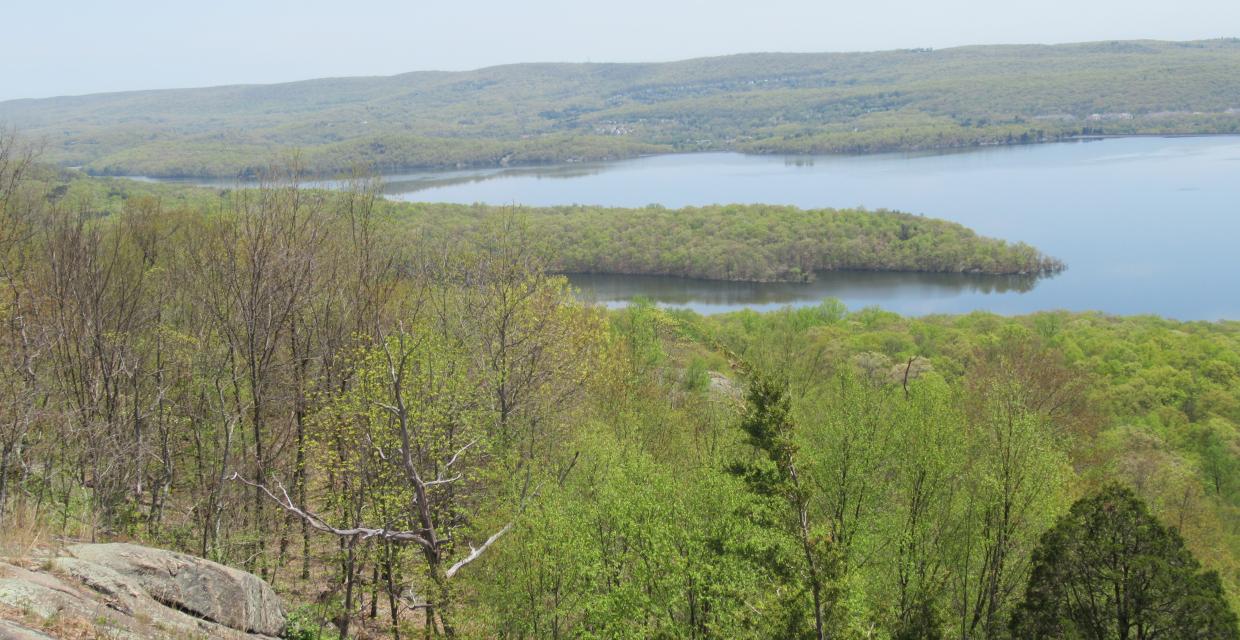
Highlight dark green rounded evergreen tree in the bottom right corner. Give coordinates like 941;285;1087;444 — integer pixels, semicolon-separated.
1012;484;1240;640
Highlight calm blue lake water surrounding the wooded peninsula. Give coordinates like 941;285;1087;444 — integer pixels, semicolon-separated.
138;136;1240;320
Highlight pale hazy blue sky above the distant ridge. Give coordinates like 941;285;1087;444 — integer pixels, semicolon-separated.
0;0;1240;100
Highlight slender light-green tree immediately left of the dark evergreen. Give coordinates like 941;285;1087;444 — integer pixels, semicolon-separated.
954;332;1078;638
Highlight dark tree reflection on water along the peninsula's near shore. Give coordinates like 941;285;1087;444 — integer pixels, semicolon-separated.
569;272;1039;305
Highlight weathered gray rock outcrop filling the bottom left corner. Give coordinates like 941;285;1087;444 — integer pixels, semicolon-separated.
0;543;284;640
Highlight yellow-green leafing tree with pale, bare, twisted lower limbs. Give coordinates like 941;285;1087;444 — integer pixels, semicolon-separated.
233;327;520;636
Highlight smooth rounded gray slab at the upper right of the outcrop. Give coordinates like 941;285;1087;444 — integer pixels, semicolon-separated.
66;543;284;636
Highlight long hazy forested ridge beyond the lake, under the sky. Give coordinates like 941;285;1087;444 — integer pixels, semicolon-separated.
0;40;1240;177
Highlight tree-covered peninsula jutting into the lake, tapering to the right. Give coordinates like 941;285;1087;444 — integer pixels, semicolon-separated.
393;203;1064;282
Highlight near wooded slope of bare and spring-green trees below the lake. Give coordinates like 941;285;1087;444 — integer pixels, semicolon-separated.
0;133;1240;640
